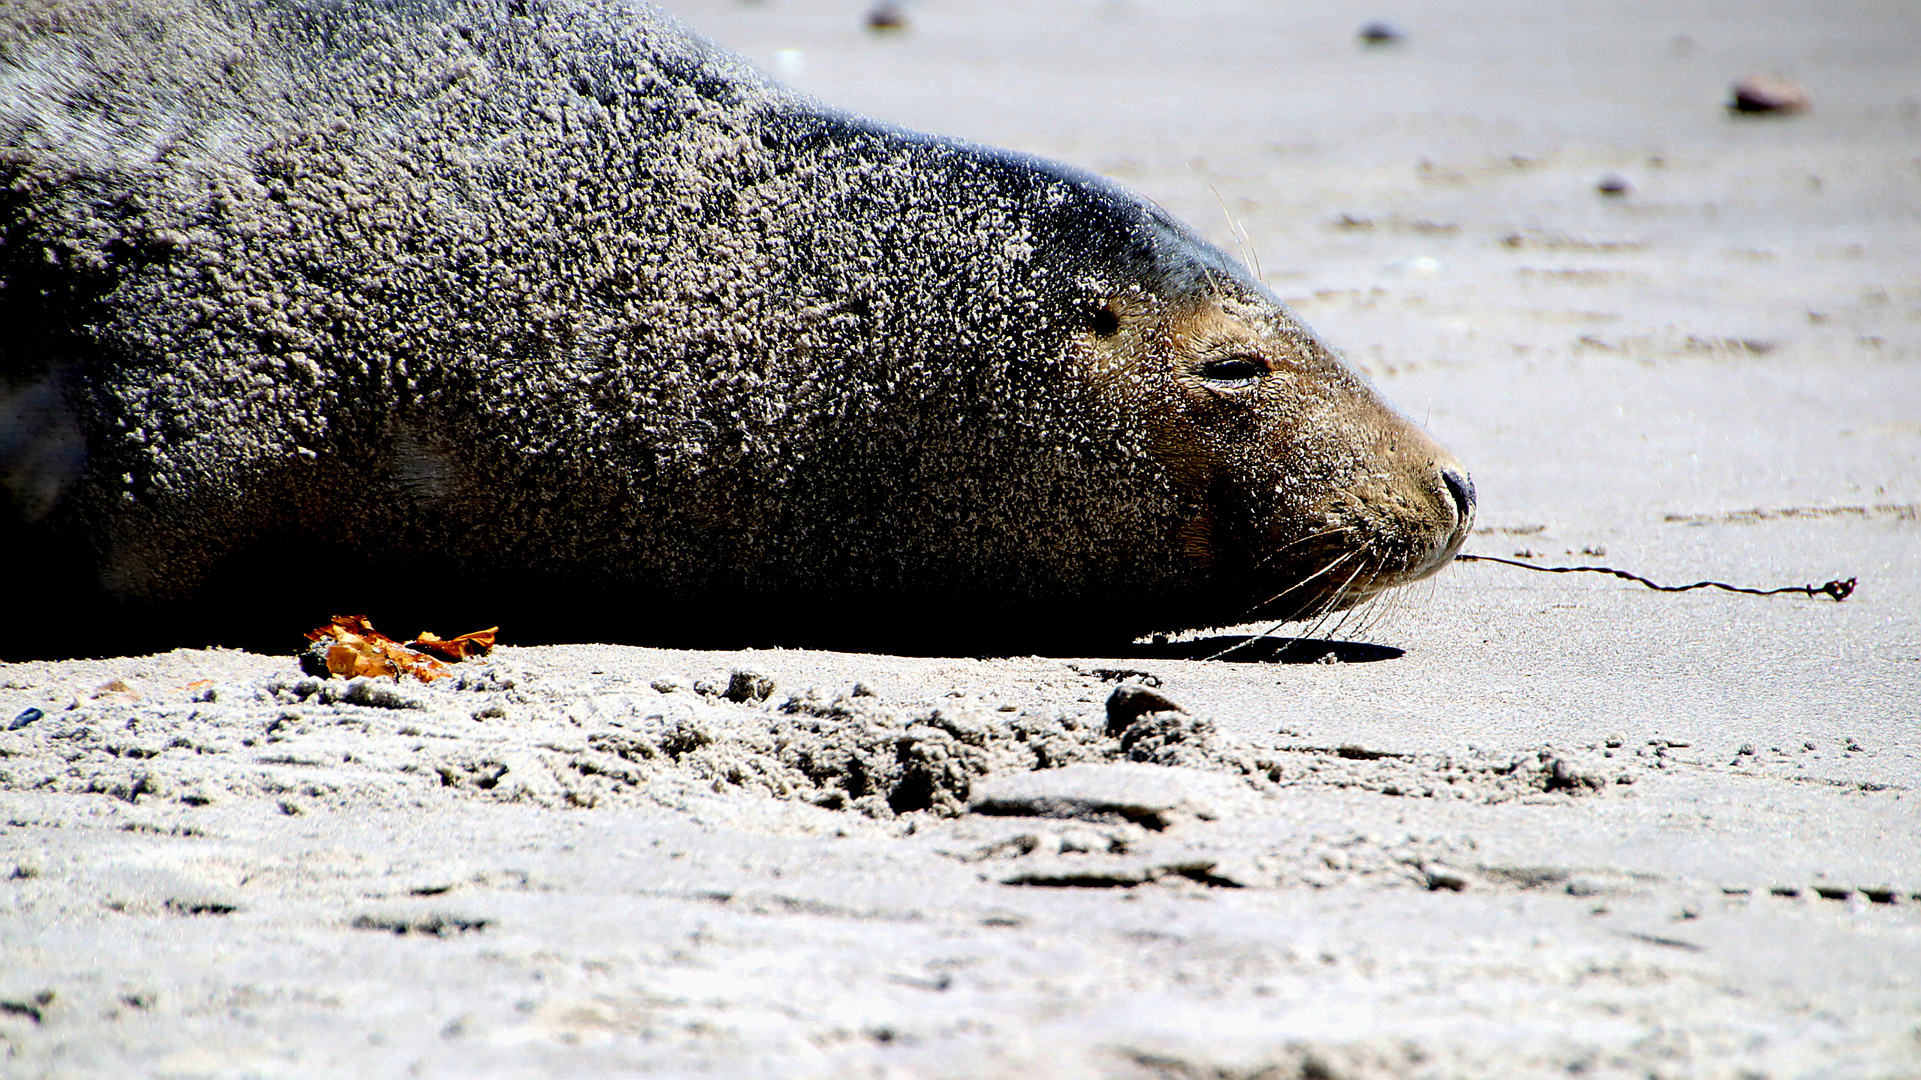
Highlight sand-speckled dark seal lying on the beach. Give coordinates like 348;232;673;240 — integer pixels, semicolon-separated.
0;0;1473;657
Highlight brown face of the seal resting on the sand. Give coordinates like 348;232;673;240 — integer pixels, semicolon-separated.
1089;282;1473;619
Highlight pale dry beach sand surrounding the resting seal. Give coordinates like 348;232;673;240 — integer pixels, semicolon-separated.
0;0;1921;1078
